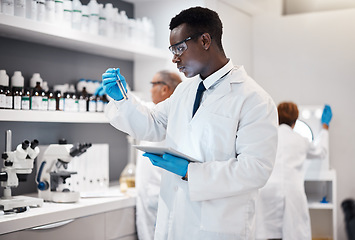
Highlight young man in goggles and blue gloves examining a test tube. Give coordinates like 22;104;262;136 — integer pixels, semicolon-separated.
102;7;278;240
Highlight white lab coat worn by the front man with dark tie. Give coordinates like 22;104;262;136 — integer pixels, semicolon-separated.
106;61;277;240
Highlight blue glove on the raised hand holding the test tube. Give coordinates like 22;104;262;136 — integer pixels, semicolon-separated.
102;68;127;101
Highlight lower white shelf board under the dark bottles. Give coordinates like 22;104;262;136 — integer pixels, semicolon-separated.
0;109;109;123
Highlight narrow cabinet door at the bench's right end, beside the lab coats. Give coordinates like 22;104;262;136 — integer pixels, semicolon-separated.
105;207;136;240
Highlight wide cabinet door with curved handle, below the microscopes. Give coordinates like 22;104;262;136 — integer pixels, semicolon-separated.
0;214;105;240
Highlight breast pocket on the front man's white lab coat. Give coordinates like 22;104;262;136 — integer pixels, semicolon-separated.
203;113;238;161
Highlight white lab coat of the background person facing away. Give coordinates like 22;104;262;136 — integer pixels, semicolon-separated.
256;124;328;240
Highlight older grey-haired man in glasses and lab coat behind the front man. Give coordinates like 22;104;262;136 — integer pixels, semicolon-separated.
136;70;181;240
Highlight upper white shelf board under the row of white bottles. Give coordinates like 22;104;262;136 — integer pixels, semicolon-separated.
0;13;170;60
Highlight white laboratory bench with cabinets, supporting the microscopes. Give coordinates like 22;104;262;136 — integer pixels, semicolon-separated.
0;186;138;240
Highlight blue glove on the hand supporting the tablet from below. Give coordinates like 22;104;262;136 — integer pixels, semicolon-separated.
143;153;189;177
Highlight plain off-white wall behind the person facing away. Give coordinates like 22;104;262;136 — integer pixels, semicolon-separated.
253;4;355;239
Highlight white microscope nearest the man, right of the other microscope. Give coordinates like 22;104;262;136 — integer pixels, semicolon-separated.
36;141;92;203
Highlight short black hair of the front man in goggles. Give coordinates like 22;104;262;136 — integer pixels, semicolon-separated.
169;7;223;51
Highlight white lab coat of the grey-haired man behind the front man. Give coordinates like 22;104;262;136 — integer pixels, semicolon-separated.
136;141;164;240
